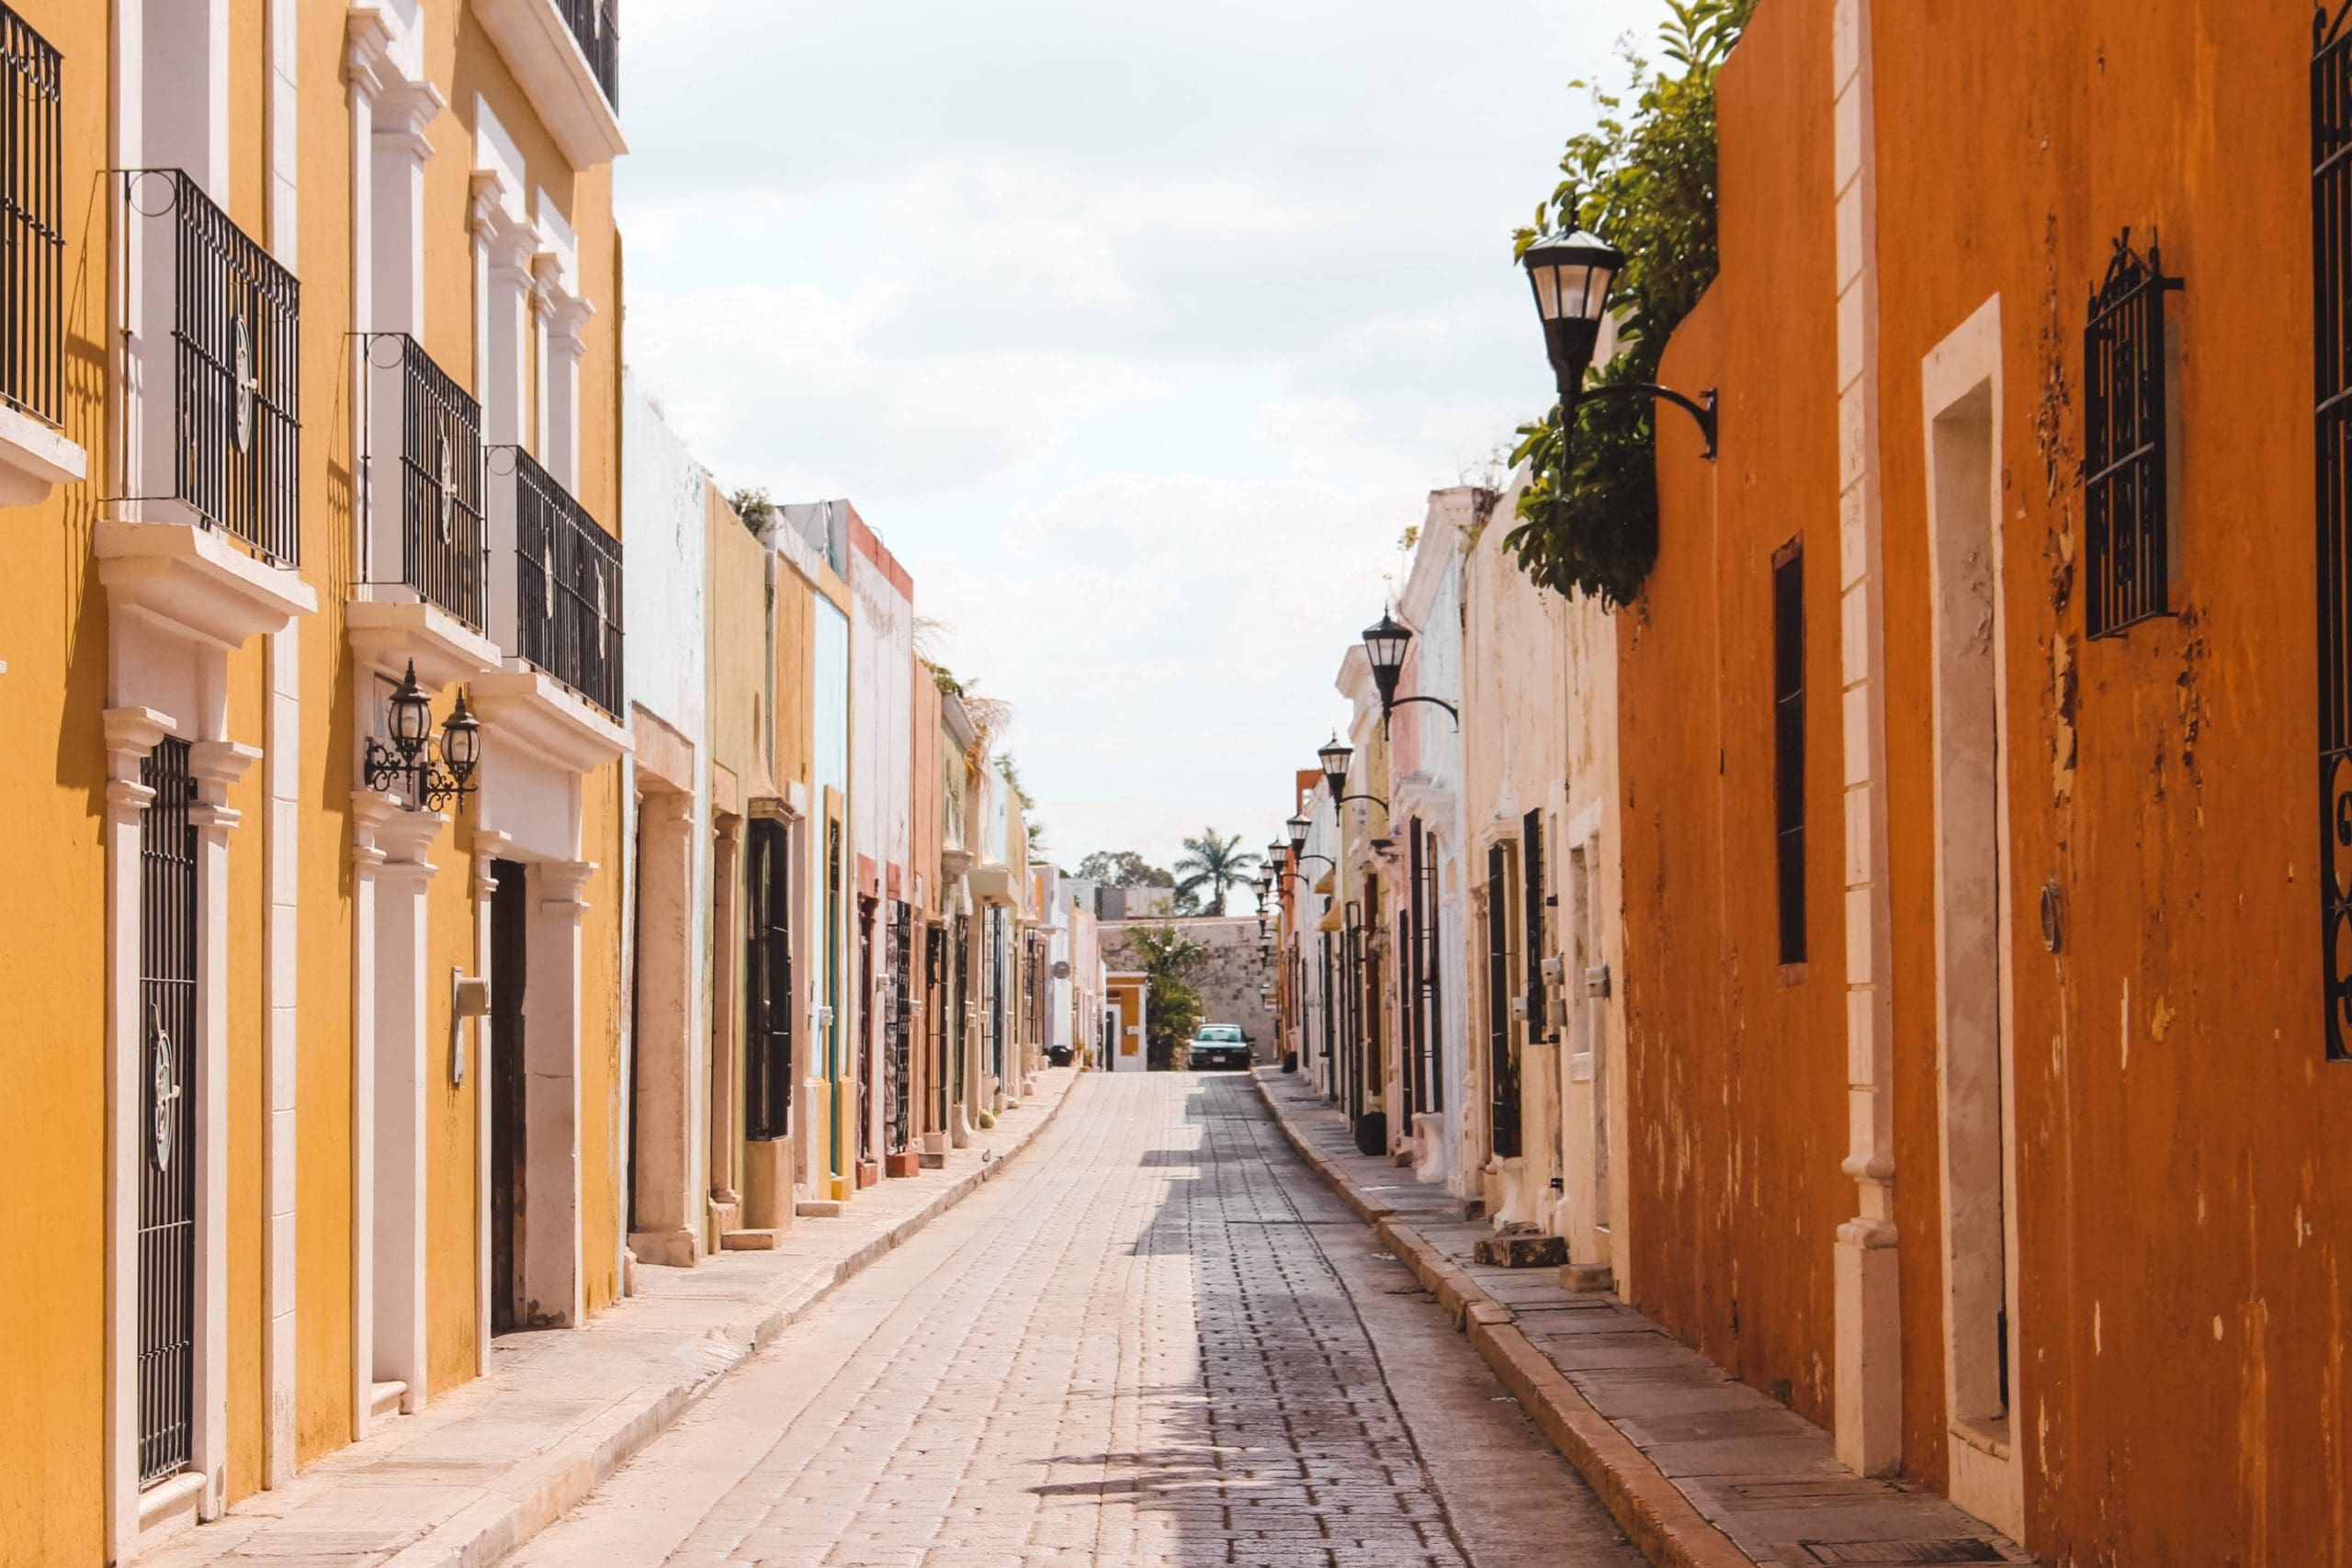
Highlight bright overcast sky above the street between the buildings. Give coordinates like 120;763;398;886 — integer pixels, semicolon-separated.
618;0;1660;865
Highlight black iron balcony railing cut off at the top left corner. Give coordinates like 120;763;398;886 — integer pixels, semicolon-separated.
0;5;66;428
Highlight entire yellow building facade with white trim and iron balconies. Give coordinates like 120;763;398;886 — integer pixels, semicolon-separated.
0;0;628;1563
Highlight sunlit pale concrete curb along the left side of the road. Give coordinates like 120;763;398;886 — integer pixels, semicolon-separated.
406;1072;1087;1568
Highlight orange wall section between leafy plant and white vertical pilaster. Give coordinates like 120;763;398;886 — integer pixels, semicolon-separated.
1618;0;1853;1422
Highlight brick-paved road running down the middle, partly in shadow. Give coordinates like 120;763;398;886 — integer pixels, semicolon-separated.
511;1075;1642;1568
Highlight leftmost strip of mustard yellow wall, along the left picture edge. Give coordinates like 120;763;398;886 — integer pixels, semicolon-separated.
0;0;106;1568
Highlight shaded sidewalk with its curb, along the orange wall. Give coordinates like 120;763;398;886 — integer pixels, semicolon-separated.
1256;1069;2032;1568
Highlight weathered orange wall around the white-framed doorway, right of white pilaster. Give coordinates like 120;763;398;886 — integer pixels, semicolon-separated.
1874;0;2352;1563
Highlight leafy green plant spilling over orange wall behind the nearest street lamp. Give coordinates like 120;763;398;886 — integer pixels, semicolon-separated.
1503;0;1755;609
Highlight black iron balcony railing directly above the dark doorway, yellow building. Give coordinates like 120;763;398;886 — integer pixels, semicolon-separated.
499;446;623;719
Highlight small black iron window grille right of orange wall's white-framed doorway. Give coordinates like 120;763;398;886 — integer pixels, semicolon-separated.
2082;228;2180;637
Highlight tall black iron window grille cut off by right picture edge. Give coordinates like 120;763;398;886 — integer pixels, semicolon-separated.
2312;0;2352;1060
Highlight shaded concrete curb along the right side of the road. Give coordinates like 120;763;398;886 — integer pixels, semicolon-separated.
1249;1072;1755;1568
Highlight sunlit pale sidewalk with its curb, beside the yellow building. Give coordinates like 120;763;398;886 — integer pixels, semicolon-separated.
139;1067;1077;1568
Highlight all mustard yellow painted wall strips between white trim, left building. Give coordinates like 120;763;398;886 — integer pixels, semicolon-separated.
0;0;621;1541
